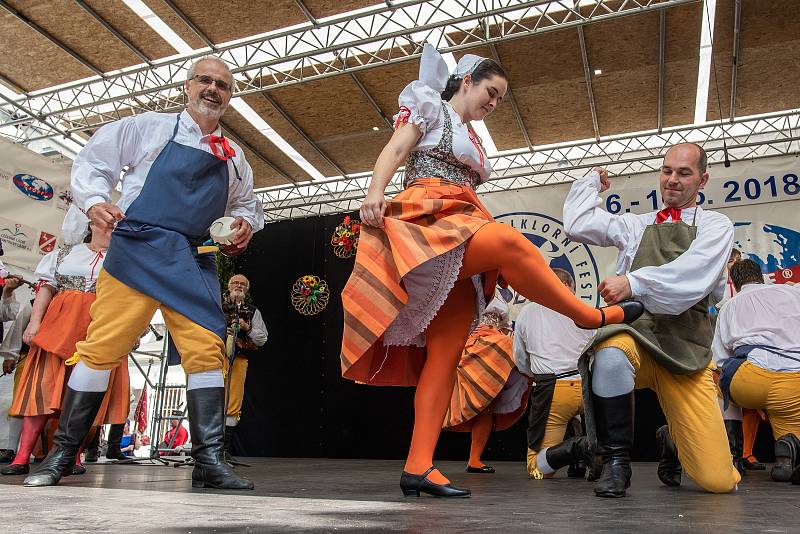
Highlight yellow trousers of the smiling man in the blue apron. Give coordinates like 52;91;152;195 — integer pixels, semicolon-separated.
76;269;225;374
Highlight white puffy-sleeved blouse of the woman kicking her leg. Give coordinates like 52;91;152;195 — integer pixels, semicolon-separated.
394;80;492;183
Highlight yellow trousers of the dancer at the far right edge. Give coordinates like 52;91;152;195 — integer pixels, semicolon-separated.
731;362;800;438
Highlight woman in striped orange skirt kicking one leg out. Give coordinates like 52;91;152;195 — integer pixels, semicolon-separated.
341;45;643;497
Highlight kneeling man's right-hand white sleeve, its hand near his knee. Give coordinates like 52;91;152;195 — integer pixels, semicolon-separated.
628;212;733;315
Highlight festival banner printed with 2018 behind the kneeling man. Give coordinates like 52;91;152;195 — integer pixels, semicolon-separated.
481;157;800;315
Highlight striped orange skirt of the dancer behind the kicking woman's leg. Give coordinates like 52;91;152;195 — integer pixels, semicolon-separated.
442;324;531;432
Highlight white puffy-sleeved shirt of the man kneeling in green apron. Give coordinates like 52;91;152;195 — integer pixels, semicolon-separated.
564;172;733;315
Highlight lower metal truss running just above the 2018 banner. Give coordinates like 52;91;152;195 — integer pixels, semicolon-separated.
256;109;800;222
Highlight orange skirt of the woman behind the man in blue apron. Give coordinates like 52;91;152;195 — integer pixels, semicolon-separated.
8;290;130;425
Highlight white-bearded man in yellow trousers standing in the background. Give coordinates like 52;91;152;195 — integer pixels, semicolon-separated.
222;274;268;462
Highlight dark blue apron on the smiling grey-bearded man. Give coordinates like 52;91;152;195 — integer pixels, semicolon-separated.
104;114;238;364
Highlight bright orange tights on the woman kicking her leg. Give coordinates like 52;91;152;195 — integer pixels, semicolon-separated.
405;223;623;484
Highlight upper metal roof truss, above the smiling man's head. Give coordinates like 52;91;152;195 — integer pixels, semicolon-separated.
0;0;698;140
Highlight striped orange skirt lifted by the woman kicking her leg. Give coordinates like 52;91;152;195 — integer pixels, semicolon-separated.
341;178;497;386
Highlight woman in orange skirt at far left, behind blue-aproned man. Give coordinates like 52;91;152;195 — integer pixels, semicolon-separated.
0;222;130;475
